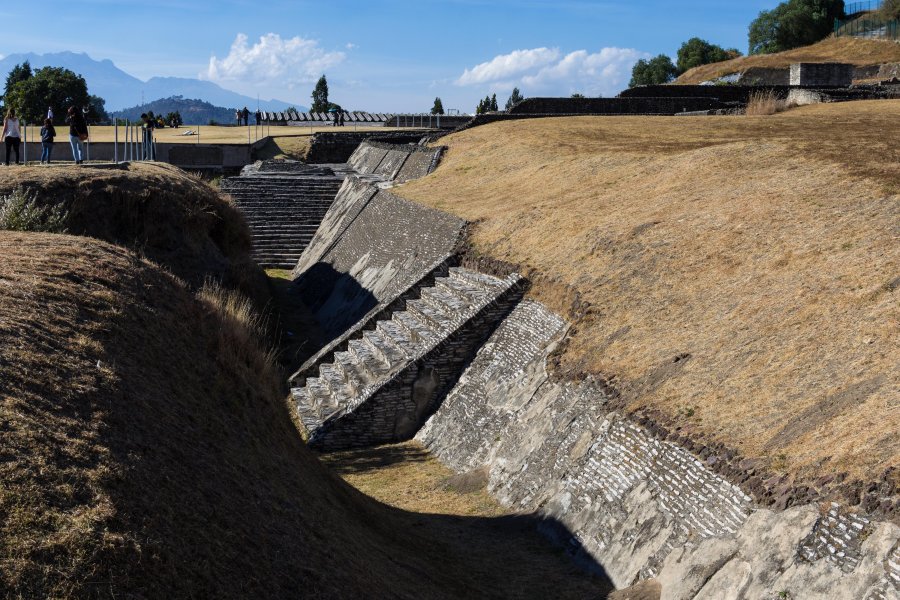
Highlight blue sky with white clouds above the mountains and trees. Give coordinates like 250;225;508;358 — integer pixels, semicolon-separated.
0;0;777;112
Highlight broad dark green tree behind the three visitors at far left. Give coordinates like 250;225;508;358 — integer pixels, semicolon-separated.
6;67;109;124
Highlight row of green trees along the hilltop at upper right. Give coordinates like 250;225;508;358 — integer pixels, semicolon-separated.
629;0;852;87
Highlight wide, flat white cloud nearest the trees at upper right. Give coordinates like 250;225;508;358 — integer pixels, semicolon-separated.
456;48;650;96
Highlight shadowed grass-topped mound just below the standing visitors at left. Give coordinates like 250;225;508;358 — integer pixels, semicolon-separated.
0;163;265;298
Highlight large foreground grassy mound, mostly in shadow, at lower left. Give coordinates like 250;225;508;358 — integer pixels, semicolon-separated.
0;232;602;598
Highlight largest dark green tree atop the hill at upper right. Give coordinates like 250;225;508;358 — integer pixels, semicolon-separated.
748;0;844;54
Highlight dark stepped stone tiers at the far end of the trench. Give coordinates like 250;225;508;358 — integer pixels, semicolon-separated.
222;172;342;269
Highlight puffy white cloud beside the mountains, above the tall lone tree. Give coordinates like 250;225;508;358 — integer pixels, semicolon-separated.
204;33;345;89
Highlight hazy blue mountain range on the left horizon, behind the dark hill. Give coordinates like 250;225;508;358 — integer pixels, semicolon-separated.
0;52;308;114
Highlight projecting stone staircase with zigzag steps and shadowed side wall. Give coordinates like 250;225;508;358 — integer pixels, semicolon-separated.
292;267;523;450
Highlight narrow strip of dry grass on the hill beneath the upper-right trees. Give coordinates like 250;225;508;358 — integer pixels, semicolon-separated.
675;37;900;84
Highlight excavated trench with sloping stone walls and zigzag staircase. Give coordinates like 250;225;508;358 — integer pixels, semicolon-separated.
241;143;900;599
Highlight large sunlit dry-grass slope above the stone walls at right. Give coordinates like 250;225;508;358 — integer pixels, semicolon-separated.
397;101;900;488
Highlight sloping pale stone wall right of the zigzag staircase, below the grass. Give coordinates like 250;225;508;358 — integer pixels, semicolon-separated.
417;301;900;599
